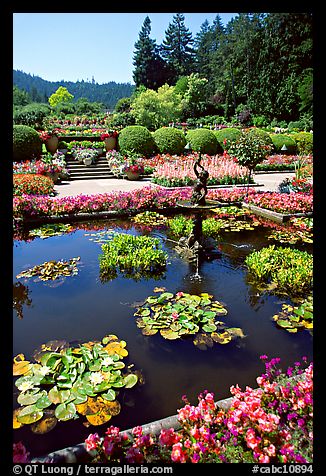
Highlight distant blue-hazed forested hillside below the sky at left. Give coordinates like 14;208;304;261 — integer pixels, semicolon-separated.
13;70;135;110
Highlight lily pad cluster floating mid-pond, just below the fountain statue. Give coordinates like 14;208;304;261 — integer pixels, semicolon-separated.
134;292;244;349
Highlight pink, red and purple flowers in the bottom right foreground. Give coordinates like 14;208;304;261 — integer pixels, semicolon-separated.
85;356;313;464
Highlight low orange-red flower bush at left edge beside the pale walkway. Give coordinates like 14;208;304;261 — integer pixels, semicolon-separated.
13;174;54;198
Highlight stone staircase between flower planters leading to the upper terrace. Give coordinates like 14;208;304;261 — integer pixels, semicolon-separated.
66;156;114;180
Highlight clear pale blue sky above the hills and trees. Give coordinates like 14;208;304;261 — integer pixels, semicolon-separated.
13;12;237;84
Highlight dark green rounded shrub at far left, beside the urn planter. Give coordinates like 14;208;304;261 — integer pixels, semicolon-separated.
13;125;42;162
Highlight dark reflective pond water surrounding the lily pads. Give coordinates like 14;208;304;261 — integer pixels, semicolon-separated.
13;215;312;456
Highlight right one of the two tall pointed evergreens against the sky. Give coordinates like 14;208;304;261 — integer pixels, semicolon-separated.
161;13;195;84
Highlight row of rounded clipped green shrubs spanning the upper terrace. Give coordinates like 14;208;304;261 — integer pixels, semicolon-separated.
13;125;313;161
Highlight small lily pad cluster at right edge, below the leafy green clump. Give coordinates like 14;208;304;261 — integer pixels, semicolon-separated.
273;296;314;333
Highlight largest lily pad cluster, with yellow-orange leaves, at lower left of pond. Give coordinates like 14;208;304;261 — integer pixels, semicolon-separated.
13;334;138;434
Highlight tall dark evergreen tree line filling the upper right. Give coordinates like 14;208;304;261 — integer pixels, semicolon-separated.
133;13;313;121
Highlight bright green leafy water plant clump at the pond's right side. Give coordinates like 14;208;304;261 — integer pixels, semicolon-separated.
245;245;313;295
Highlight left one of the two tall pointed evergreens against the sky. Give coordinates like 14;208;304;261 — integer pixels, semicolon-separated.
133;16;167;90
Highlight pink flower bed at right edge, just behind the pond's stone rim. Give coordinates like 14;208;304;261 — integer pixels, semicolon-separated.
246;192;313;213
